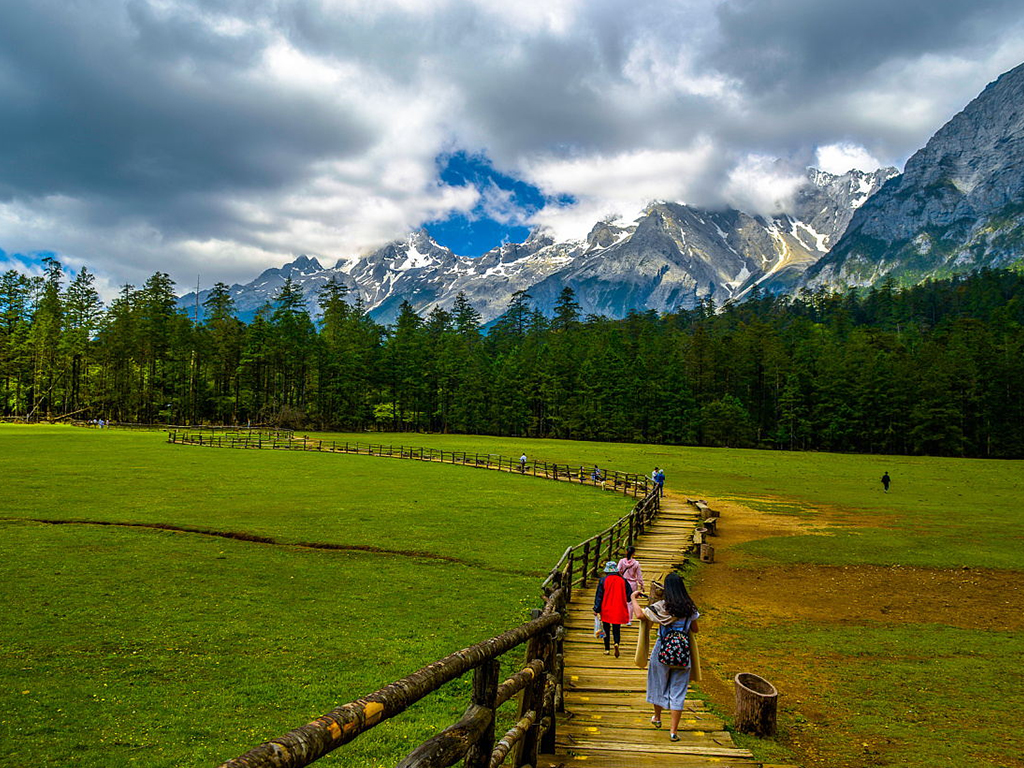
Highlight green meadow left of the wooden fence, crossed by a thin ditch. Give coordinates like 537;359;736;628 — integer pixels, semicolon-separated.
0;425;632;767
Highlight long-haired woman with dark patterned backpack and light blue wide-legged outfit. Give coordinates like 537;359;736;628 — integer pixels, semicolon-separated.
632;573;700;741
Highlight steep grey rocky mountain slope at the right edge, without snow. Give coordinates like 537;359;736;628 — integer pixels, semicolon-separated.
804;65;1024;287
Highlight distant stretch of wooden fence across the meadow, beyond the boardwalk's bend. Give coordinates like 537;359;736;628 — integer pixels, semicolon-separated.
167;427;654;499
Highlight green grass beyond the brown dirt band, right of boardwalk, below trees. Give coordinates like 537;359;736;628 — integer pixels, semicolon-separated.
310;434;1024;570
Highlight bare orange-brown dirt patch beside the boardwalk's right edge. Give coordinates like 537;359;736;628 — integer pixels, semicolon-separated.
679;499;1024;768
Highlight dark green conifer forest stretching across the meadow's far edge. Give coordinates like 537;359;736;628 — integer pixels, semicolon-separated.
0;259;1024;457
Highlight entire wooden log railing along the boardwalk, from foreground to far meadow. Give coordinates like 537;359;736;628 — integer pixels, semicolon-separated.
168;429;660;768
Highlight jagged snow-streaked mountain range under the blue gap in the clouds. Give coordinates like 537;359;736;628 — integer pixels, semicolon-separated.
181;168;896;323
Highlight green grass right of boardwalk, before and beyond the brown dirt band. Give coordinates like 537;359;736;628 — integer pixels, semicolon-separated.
307;435;1024;768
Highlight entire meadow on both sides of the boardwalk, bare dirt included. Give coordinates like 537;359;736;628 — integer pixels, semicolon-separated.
0;427;1024;768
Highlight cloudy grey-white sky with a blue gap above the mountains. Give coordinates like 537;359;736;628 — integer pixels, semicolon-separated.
0;0;1024;292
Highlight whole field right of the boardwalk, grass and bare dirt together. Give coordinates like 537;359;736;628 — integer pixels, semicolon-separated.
307;435;1024;768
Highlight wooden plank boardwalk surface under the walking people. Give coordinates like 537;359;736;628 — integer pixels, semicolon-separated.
537;495;761;768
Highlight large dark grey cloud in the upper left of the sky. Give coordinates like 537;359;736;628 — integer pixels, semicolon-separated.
0;2;369;231
